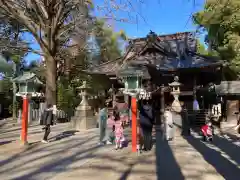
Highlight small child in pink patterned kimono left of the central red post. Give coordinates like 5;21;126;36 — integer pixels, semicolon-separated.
113;111;124;150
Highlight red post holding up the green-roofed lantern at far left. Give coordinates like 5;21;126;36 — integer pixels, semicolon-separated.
21;96;28;145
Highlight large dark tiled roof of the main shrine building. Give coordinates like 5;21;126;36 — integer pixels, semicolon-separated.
86;32;219;75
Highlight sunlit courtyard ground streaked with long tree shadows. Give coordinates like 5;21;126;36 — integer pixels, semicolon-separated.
0;123;240;180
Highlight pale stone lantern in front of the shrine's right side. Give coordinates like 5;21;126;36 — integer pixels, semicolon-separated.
169;76;182;113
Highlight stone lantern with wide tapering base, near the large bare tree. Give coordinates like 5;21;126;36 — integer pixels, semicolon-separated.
72;81;97;131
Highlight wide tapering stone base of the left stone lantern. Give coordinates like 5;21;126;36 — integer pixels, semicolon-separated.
71;107;97;131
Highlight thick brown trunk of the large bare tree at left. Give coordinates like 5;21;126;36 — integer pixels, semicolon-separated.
45;55;57;105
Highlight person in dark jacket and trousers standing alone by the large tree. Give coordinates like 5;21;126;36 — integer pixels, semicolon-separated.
40;104;53;143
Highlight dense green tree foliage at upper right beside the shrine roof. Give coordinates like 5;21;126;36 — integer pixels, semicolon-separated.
193;0;240;72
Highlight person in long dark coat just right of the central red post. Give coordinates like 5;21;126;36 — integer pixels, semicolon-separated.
139;100;154;151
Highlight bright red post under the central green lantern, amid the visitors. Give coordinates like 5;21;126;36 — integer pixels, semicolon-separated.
131;97;137;152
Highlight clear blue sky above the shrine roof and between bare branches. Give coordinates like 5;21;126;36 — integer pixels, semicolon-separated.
24;0;204;62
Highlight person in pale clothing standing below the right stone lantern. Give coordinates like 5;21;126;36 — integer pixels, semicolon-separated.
164;107;174;141
